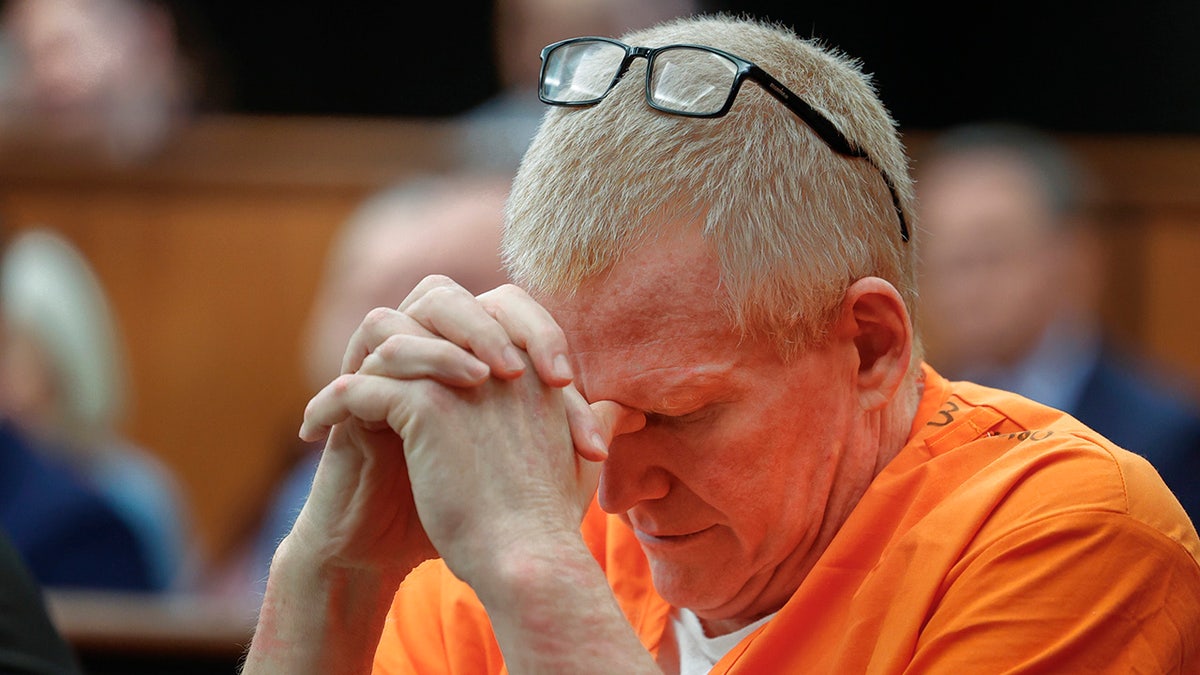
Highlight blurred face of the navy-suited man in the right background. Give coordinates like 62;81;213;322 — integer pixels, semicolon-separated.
917;154;1080;375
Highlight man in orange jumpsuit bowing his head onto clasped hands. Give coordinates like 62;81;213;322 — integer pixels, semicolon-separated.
245;17;1200;674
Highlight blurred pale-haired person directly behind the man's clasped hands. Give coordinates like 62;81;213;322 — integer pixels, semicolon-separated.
220;172;511;602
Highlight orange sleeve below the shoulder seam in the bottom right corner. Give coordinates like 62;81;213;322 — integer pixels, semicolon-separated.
907;512;1200;675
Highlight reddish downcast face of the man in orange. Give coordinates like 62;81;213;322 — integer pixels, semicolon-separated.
546;224;877;620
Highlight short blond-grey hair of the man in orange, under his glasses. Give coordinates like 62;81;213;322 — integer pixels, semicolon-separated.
503;14;919;360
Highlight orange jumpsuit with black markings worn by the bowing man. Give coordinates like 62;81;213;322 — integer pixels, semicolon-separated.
374;366;1200;675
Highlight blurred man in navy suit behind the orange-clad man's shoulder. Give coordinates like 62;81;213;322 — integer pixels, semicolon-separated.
914;121;1200;522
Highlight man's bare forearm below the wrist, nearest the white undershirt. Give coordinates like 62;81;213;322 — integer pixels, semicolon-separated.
476;530;661;675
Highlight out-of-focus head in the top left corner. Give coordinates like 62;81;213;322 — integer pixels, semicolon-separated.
0;0;218;163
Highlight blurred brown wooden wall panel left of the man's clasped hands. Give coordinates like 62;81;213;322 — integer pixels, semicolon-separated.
0;114;456;562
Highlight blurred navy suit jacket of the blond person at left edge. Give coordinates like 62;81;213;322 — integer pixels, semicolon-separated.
0;422;154;591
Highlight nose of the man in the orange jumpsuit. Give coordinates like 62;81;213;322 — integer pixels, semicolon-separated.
596;430;671;514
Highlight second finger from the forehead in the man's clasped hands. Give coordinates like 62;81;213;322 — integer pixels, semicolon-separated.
400;275;526;380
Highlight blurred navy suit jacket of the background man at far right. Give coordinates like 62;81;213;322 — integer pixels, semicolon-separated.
1068;345;1200;524
